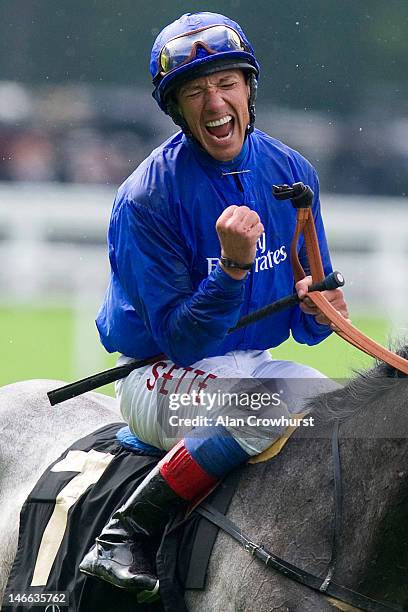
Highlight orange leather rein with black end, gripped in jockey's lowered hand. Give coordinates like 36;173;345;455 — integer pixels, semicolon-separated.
274;183;408;374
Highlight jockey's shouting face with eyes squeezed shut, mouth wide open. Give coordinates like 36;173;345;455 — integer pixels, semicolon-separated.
177;70;250;161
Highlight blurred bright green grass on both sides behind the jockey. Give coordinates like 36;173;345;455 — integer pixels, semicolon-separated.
0;307;388;394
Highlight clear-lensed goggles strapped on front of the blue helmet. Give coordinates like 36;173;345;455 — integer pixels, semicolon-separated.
157;25;247;76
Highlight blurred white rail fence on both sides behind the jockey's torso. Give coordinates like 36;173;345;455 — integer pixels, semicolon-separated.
0;183;408;372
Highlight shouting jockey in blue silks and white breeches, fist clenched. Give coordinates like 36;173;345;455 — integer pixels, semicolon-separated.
80;12;348;593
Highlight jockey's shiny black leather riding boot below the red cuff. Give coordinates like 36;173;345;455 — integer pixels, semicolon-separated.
79;467;187;595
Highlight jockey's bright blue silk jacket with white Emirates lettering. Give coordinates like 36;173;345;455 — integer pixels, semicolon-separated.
96;130;332;366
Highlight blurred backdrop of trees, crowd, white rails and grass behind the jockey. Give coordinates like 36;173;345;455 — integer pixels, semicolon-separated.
0;0;408;384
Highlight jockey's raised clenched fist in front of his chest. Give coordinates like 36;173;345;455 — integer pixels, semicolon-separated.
215;205;264;279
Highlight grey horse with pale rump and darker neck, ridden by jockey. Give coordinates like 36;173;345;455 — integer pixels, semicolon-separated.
0;350;408;612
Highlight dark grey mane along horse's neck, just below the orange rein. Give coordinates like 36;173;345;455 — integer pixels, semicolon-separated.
306;345;408;422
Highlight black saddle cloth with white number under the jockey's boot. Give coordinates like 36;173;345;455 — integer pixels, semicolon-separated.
1;423;237;612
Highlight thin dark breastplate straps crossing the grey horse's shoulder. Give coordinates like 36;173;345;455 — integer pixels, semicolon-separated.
194;422;403;612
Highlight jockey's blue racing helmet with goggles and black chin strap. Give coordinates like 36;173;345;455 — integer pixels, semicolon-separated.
150;12;259;131
